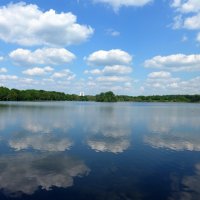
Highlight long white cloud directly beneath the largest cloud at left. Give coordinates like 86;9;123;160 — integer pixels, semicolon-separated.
9;48;76;66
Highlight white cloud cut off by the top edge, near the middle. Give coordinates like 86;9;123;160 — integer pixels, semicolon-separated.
93;0;152;11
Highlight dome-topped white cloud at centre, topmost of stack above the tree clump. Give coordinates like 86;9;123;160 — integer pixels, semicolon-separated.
86;49;132;66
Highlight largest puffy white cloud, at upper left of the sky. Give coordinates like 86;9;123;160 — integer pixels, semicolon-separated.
0;3;94;46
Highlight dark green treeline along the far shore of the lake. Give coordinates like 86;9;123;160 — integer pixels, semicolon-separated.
0;87;200;102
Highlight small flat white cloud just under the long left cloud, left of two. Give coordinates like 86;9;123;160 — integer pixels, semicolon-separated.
22;66;54;76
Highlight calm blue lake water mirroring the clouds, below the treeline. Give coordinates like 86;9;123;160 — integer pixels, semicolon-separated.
0;102;200;200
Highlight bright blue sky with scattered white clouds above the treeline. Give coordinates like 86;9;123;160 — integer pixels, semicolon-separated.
0;0;200;96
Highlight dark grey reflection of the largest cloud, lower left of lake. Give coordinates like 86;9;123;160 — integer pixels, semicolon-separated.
0;153;90;195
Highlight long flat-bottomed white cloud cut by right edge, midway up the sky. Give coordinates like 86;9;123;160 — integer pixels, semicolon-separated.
144;54;200;71
